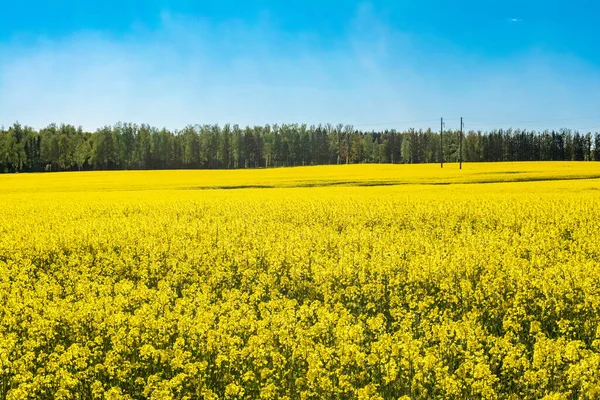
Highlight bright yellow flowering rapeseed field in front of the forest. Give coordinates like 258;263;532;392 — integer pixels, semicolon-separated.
0;162;600;399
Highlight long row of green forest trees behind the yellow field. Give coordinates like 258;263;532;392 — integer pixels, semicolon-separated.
0;123;600;172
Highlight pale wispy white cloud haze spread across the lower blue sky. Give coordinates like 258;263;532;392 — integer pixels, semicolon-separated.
0;6;600;130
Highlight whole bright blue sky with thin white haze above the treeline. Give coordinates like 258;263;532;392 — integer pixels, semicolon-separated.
0;0;600;131
